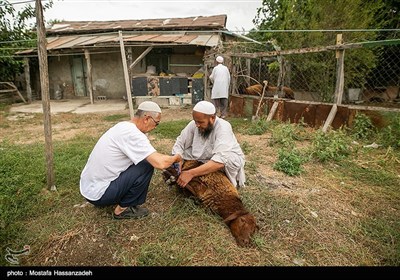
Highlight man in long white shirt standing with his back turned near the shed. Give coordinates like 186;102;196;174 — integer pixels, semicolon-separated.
210;56;231;119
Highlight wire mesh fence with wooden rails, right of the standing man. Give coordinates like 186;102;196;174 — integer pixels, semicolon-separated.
227;31;400;105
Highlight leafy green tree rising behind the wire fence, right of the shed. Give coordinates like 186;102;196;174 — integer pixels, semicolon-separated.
249;0;395;101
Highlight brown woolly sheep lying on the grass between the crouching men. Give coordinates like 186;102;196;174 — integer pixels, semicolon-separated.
162;160;258;247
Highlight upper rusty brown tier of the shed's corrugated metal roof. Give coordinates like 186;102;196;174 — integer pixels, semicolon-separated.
46;15;227;35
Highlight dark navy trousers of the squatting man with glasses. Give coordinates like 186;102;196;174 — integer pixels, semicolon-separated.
88;160;154;207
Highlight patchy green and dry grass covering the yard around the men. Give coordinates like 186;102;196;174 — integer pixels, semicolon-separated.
0;110;400;266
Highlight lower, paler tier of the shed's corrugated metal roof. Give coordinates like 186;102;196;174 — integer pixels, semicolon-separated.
43;33;220;51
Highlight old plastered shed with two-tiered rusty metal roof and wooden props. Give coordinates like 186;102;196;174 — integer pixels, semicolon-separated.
18;15;250;105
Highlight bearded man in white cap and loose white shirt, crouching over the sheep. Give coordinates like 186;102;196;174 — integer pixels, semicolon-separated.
172;101;246;188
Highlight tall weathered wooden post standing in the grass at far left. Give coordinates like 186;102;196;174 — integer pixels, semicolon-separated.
35;0;56;190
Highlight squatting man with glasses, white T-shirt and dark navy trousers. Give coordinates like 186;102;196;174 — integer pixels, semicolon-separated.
80;101;182;219
